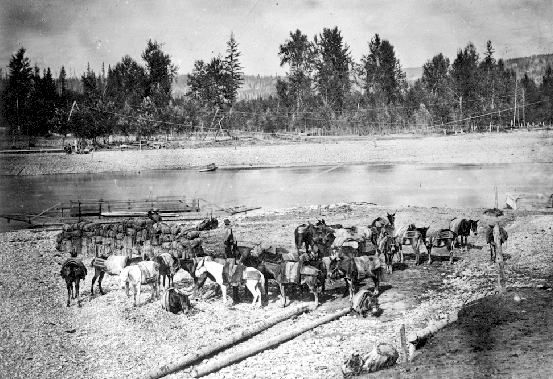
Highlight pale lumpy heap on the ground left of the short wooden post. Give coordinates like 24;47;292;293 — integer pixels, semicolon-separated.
342;343;399;378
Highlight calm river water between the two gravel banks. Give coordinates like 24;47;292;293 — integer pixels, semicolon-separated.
0;164;553;231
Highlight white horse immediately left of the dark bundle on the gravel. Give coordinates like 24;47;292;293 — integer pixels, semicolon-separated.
119;261;159;307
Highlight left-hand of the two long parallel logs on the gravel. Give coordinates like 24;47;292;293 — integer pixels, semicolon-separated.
142;304;316;379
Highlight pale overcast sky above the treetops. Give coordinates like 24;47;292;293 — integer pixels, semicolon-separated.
0;0;553;75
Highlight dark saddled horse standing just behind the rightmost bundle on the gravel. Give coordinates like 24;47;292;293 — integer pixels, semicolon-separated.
329;255;382;303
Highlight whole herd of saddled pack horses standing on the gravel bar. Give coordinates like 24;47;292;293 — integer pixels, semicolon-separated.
61;213;507;316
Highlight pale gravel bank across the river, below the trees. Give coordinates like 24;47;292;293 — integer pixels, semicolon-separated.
0;130;553;175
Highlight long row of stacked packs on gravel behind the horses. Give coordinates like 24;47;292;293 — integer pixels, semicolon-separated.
56;219;202;258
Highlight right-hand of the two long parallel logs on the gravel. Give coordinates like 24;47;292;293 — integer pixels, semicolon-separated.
191;307;350;378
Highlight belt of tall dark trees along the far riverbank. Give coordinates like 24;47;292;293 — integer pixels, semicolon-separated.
0;27;553;139
